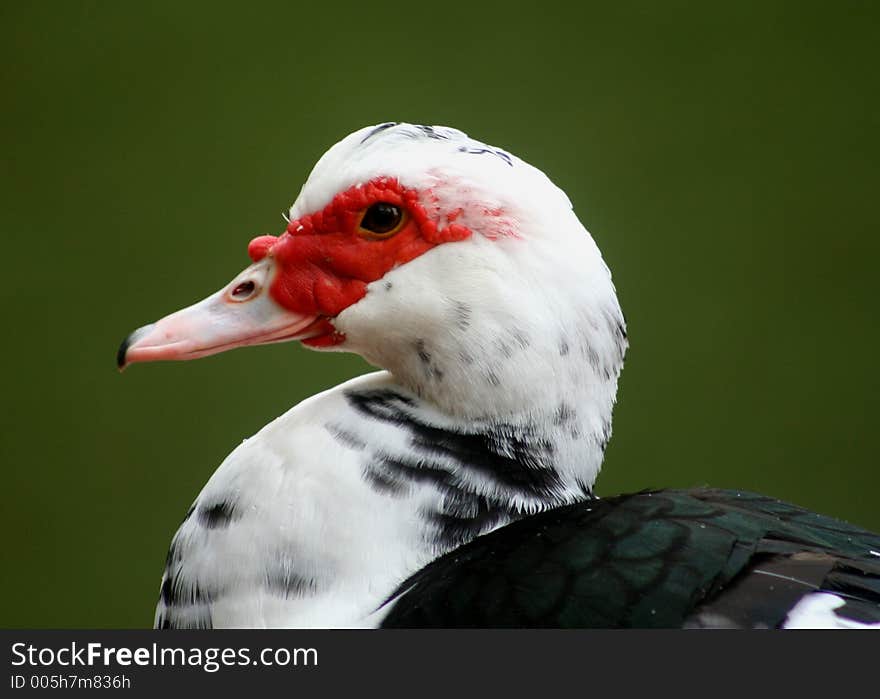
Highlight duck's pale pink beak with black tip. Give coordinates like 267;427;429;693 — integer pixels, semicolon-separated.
116;257;317;371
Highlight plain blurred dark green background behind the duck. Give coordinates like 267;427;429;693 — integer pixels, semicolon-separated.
0;2;880;627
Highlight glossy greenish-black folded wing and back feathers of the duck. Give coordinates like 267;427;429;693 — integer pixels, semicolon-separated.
383;489;880;628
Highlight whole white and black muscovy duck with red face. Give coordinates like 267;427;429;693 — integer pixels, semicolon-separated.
117;123;880;628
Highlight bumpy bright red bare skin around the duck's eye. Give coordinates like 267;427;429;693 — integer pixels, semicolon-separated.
248;177;471;347
